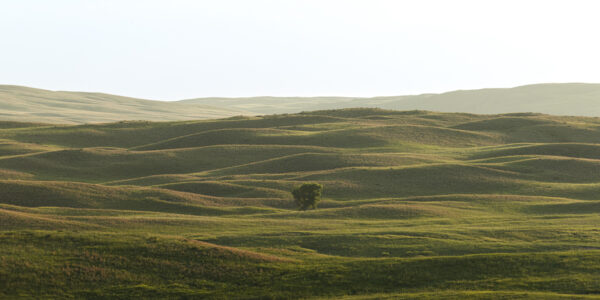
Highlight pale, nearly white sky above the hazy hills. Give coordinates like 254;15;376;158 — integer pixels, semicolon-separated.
0;0;600;100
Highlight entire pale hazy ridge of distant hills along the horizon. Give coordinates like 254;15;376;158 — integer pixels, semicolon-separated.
0;83;600;124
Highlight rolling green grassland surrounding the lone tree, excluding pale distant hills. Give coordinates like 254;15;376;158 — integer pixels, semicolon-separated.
0;109;600;299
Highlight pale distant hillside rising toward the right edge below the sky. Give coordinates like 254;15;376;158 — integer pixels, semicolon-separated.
181;83;600;116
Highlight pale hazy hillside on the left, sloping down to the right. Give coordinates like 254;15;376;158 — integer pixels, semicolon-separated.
0;85;242;124
